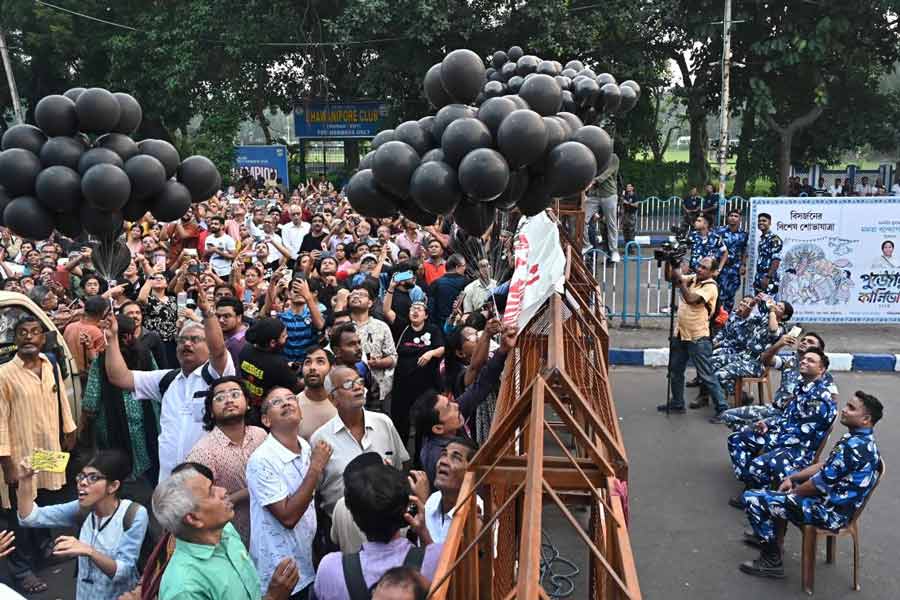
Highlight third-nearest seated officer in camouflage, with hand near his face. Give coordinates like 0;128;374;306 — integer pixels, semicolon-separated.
722;332;836;431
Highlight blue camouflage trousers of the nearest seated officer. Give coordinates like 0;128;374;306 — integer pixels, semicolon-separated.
744;490;847;542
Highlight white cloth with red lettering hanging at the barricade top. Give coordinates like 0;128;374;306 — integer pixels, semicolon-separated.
503;211;566;331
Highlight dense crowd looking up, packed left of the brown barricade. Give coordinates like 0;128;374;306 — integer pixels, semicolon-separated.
0;181;517;600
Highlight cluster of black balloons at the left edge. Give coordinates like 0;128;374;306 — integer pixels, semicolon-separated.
0;88;222;240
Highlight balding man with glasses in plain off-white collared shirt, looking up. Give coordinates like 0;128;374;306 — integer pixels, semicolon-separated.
310;365;409;515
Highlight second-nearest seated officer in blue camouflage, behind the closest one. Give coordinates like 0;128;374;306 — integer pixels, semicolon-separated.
728;350;837;508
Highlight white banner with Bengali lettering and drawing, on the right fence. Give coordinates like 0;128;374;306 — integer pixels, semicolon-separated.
747;197;900;323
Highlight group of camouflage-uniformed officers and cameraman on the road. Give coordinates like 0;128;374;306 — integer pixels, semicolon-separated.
657;211;883;578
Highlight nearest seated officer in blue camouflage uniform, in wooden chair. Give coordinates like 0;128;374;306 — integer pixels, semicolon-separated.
740;392;884;578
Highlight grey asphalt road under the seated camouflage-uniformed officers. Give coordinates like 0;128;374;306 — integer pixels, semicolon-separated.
620;368;900;600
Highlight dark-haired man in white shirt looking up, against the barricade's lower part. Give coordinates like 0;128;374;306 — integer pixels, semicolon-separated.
425;437;483;543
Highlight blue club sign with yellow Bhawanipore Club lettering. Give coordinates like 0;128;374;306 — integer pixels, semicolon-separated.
294;101;388;139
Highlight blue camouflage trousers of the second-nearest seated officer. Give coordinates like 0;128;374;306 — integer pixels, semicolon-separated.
728;427;806;489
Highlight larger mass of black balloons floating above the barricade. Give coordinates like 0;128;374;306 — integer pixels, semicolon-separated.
347;47;640;236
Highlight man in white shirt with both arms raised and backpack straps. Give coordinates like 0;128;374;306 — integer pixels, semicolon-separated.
104;294;235;481
